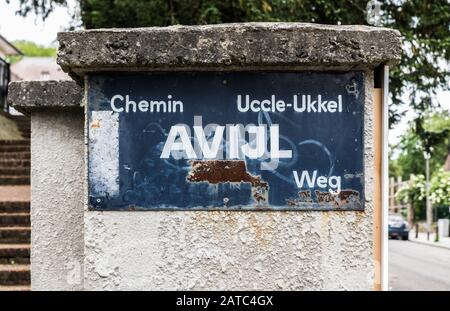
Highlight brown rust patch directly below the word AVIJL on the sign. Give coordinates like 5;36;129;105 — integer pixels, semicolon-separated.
187;160;269;203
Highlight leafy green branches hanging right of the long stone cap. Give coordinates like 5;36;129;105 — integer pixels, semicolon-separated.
385;0;450;125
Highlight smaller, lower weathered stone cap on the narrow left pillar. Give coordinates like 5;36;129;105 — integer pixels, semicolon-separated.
8;81;83;114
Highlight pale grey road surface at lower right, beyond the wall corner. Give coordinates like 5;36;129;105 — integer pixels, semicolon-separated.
389;240;450;291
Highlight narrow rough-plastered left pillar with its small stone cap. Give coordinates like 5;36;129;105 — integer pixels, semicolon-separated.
10;81;84;290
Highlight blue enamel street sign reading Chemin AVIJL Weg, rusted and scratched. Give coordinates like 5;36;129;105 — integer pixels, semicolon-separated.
87;71;364;210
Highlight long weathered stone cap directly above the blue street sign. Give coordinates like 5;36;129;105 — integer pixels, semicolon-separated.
58;23;401;77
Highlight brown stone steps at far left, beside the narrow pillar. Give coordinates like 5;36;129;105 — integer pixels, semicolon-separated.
0;116;31;291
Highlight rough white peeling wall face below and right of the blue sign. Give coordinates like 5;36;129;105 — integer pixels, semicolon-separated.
84;71;375;290
